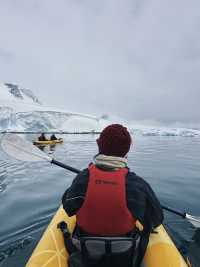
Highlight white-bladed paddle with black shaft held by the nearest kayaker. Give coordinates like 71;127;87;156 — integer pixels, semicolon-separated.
1;133;200;228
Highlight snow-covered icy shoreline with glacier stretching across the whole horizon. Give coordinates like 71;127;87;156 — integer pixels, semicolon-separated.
0;83;200;137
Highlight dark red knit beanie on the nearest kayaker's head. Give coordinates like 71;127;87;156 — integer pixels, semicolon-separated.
97;124;131;157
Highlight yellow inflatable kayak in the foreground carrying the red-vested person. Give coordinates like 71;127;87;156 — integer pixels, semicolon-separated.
26;206;191;267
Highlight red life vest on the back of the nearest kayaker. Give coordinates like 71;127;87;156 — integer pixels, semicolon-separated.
77;164;135;236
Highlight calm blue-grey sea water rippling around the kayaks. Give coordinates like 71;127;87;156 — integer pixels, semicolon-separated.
0;135;200;267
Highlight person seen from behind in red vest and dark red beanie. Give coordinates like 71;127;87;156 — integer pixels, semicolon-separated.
62;124;163;266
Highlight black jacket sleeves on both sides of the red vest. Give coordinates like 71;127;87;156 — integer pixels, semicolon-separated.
62;169;163;235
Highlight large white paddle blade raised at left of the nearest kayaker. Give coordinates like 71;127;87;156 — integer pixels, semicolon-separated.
1;134;52;162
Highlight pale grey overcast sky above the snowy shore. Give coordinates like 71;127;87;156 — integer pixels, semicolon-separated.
0;0;200;121
